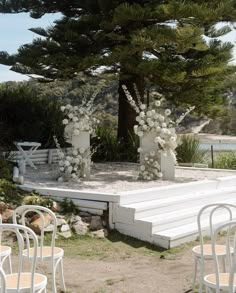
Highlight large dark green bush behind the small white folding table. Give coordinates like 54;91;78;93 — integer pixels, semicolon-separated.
0;84;64;150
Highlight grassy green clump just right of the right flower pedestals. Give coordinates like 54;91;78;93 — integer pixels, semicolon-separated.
176;135;206;163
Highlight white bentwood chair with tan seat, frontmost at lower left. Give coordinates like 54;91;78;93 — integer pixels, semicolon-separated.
0;224;47;293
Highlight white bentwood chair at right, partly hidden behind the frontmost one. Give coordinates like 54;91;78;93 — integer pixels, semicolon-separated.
192;203;236;293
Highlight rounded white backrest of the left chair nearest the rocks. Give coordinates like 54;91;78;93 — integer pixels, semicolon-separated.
13;205;57;258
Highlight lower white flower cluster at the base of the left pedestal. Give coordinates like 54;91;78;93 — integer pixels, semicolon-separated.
54;137;91;182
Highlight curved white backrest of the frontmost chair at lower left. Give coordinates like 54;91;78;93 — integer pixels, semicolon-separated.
0;224;38;293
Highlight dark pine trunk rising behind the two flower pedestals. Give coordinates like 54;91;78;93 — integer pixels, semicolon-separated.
117;74;144;143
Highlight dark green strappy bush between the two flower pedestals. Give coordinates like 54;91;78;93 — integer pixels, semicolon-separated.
91;126;139;162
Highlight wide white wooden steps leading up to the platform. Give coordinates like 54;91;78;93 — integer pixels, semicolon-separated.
114;176;236;248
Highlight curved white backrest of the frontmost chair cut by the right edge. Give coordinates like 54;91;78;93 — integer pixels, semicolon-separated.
212;220;236;293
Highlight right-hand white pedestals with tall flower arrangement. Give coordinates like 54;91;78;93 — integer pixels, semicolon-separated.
123;85;194;180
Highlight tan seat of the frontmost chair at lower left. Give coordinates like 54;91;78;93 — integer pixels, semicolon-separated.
6;273;47;292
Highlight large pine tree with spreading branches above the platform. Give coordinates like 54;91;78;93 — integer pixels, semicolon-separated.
0;0;236;139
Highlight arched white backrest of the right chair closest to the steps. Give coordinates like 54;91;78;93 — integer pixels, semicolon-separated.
197;203;236;252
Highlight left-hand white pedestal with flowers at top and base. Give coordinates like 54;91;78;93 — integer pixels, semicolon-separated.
55;98;99;182
